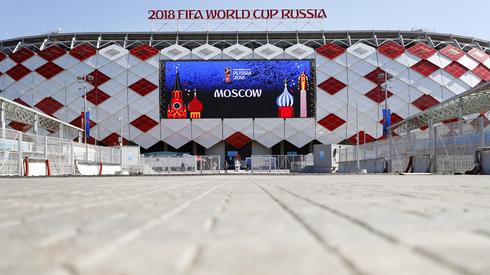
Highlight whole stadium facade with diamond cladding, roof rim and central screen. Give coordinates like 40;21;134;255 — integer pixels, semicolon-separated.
0;31;490;160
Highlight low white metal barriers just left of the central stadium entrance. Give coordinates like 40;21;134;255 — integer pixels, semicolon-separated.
141;155;221;174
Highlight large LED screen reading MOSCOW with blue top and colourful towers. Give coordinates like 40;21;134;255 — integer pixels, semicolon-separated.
161;60;315;119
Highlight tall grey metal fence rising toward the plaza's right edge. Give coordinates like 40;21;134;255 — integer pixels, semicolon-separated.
339;117;490;174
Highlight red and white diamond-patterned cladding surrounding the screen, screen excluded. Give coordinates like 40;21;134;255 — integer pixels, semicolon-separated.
0;41;490;148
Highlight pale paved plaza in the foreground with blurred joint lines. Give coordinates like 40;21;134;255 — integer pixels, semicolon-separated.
0;175;490;275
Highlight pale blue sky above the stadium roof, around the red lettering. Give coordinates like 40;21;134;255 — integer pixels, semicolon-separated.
0;0;490;40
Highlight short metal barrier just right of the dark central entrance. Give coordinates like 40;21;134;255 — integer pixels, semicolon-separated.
246;154;313;172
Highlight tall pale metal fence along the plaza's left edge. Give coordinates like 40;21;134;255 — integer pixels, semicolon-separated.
0;129;121;176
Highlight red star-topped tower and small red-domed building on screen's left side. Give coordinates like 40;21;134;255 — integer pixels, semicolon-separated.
167;71;203;119
